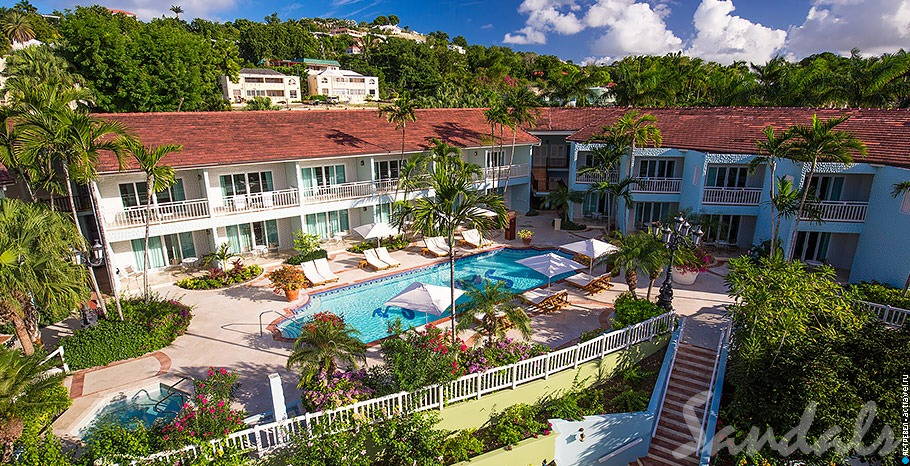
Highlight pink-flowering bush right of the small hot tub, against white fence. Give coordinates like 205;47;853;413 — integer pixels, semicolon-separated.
161;394;245;447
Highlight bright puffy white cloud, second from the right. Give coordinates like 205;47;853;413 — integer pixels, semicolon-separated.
685;0;787;64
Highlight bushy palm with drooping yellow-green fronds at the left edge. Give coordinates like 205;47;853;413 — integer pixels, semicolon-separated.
0;199;88;354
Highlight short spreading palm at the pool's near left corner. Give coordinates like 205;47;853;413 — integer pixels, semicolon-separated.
287;314;366;388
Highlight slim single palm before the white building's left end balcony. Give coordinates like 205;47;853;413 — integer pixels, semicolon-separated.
126;141;183;300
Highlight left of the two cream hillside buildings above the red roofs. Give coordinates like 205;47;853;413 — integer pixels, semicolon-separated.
221;68;300;104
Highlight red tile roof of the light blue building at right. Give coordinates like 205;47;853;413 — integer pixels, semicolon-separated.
531;107;910;168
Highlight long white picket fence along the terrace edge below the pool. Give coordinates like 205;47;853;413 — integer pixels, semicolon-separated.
131;313;679;464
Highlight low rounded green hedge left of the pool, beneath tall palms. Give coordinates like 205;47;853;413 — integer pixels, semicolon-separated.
60;298;192;370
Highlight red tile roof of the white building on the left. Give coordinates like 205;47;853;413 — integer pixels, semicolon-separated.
97;108;539;172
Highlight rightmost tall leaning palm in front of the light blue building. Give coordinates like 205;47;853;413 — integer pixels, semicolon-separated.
787;115;867;258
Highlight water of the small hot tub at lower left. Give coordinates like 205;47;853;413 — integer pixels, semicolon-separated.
79;385;186;437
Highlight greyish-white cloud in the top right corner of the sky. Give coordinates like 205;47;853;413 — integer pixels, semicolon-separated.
787;0;910;58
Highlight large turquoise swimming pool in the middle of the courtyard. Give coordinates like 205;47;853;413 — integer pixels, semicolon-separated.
278;248;571;342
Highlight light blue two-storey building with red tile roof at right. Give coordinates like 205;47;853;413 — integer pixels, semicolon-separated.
529;108;910;286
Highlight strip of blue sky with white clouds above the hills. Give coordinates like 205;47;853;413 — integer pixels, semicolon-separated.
19;0;910;63
